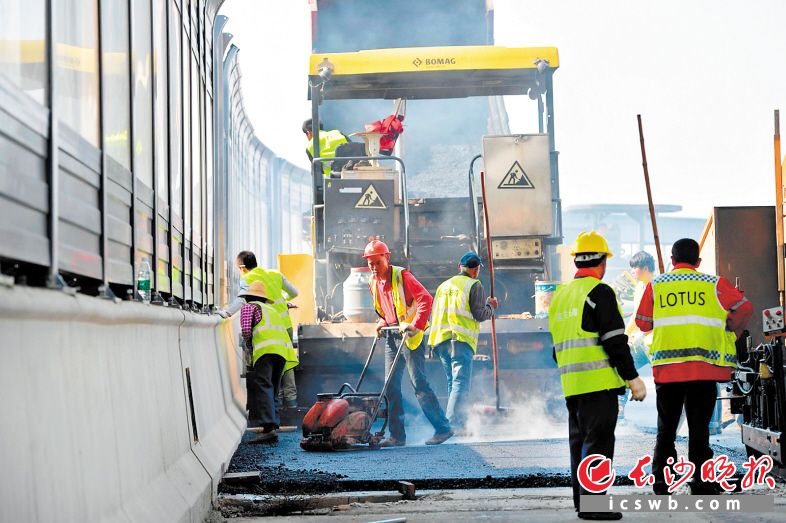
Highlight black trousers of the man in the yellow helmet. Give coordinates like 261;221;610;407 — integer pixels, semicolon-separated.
565;390;619;510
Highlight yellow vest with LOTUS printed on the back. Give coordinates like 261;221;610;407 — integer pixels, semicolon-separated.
650;269;737;367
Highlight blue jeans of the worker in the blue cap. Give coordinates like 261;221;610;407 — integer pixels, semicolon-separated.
434;340;474;429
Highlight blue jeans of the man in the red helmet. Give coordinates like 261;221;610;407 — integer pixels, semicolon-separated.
385;333;450;441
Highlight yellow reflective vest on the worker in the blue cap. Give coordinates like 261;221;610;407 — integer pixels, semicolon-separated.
428;274;480;352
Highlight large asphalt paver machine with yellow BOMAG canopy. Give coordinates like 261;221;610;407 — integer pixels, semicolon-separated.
298;45;562;414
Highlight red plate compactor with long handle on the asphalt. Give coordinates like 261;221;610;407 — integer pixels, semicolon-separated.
300;327;407;452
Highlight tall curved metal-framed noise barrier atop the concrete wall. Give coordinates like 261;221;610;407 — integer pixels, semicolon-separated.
0;0;311;312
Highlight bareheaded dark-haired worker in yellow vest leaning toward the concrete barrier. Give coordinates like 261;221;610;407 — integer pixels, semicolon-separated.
228;251;298;408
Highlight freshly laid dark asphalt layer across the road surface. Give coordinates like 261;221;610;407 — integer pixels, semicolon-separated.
219;433;745;496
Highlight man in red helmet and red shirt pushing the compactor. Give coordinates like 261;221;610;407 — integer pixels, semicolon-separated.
363;240;453;447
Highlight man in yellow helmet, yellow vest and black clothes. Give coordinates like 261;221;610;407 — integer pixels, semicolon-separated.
549;231;647;519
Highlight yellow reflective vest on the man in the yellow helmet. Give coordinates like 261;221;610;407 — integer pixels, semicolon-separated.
549;277;625;398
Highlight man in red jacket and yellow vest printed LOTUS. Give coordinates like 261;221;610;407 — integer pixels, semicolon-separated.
636;238;753;495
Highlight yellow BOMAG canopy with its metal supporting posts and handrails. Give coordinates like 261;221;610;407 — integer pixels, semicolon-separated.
308;46;563;286
